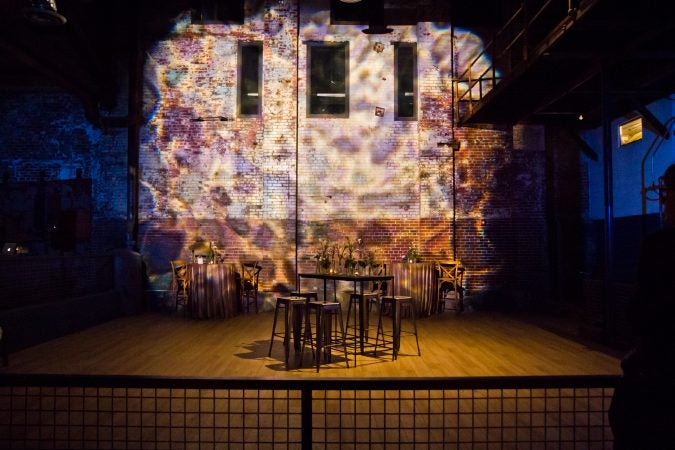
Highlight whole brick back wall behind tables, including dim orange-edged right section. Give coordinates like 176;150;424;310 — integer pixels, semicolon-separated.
139;0;547;308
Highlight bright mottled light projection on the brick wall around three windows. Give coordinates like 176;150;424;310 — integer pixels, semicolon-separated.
139;1;496;292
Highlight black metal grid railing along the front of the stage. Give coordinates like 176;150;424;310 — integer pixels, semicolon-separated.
0;374;618;449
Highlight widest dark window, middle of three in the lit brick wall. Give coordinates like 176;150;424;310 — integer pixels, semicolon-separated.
307;42;349;117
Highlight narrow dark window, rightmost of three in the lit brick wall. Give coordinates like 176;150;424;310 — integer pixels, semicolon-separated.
394;42;417;120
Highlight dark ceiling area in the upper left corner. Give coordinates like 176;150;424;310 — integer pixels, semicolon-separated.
0;0;189;121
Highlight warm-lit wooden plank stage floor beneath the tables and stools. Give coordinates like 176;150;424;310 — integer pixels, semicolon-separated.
0;311;621;378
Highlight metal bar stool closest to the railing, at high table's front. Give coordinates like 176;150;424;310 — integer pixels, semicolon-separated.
302;301;349;373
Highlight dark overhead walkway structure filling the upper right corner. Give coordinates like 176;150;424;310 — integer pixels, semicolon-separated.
454;0;675;128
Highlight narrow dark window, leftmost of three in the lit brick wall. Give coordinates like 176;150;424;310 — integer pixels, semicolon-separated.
238;42;262;116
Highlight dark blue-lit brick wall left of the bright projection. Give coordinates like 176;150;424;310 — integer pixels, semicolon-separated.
0;90;127;252
